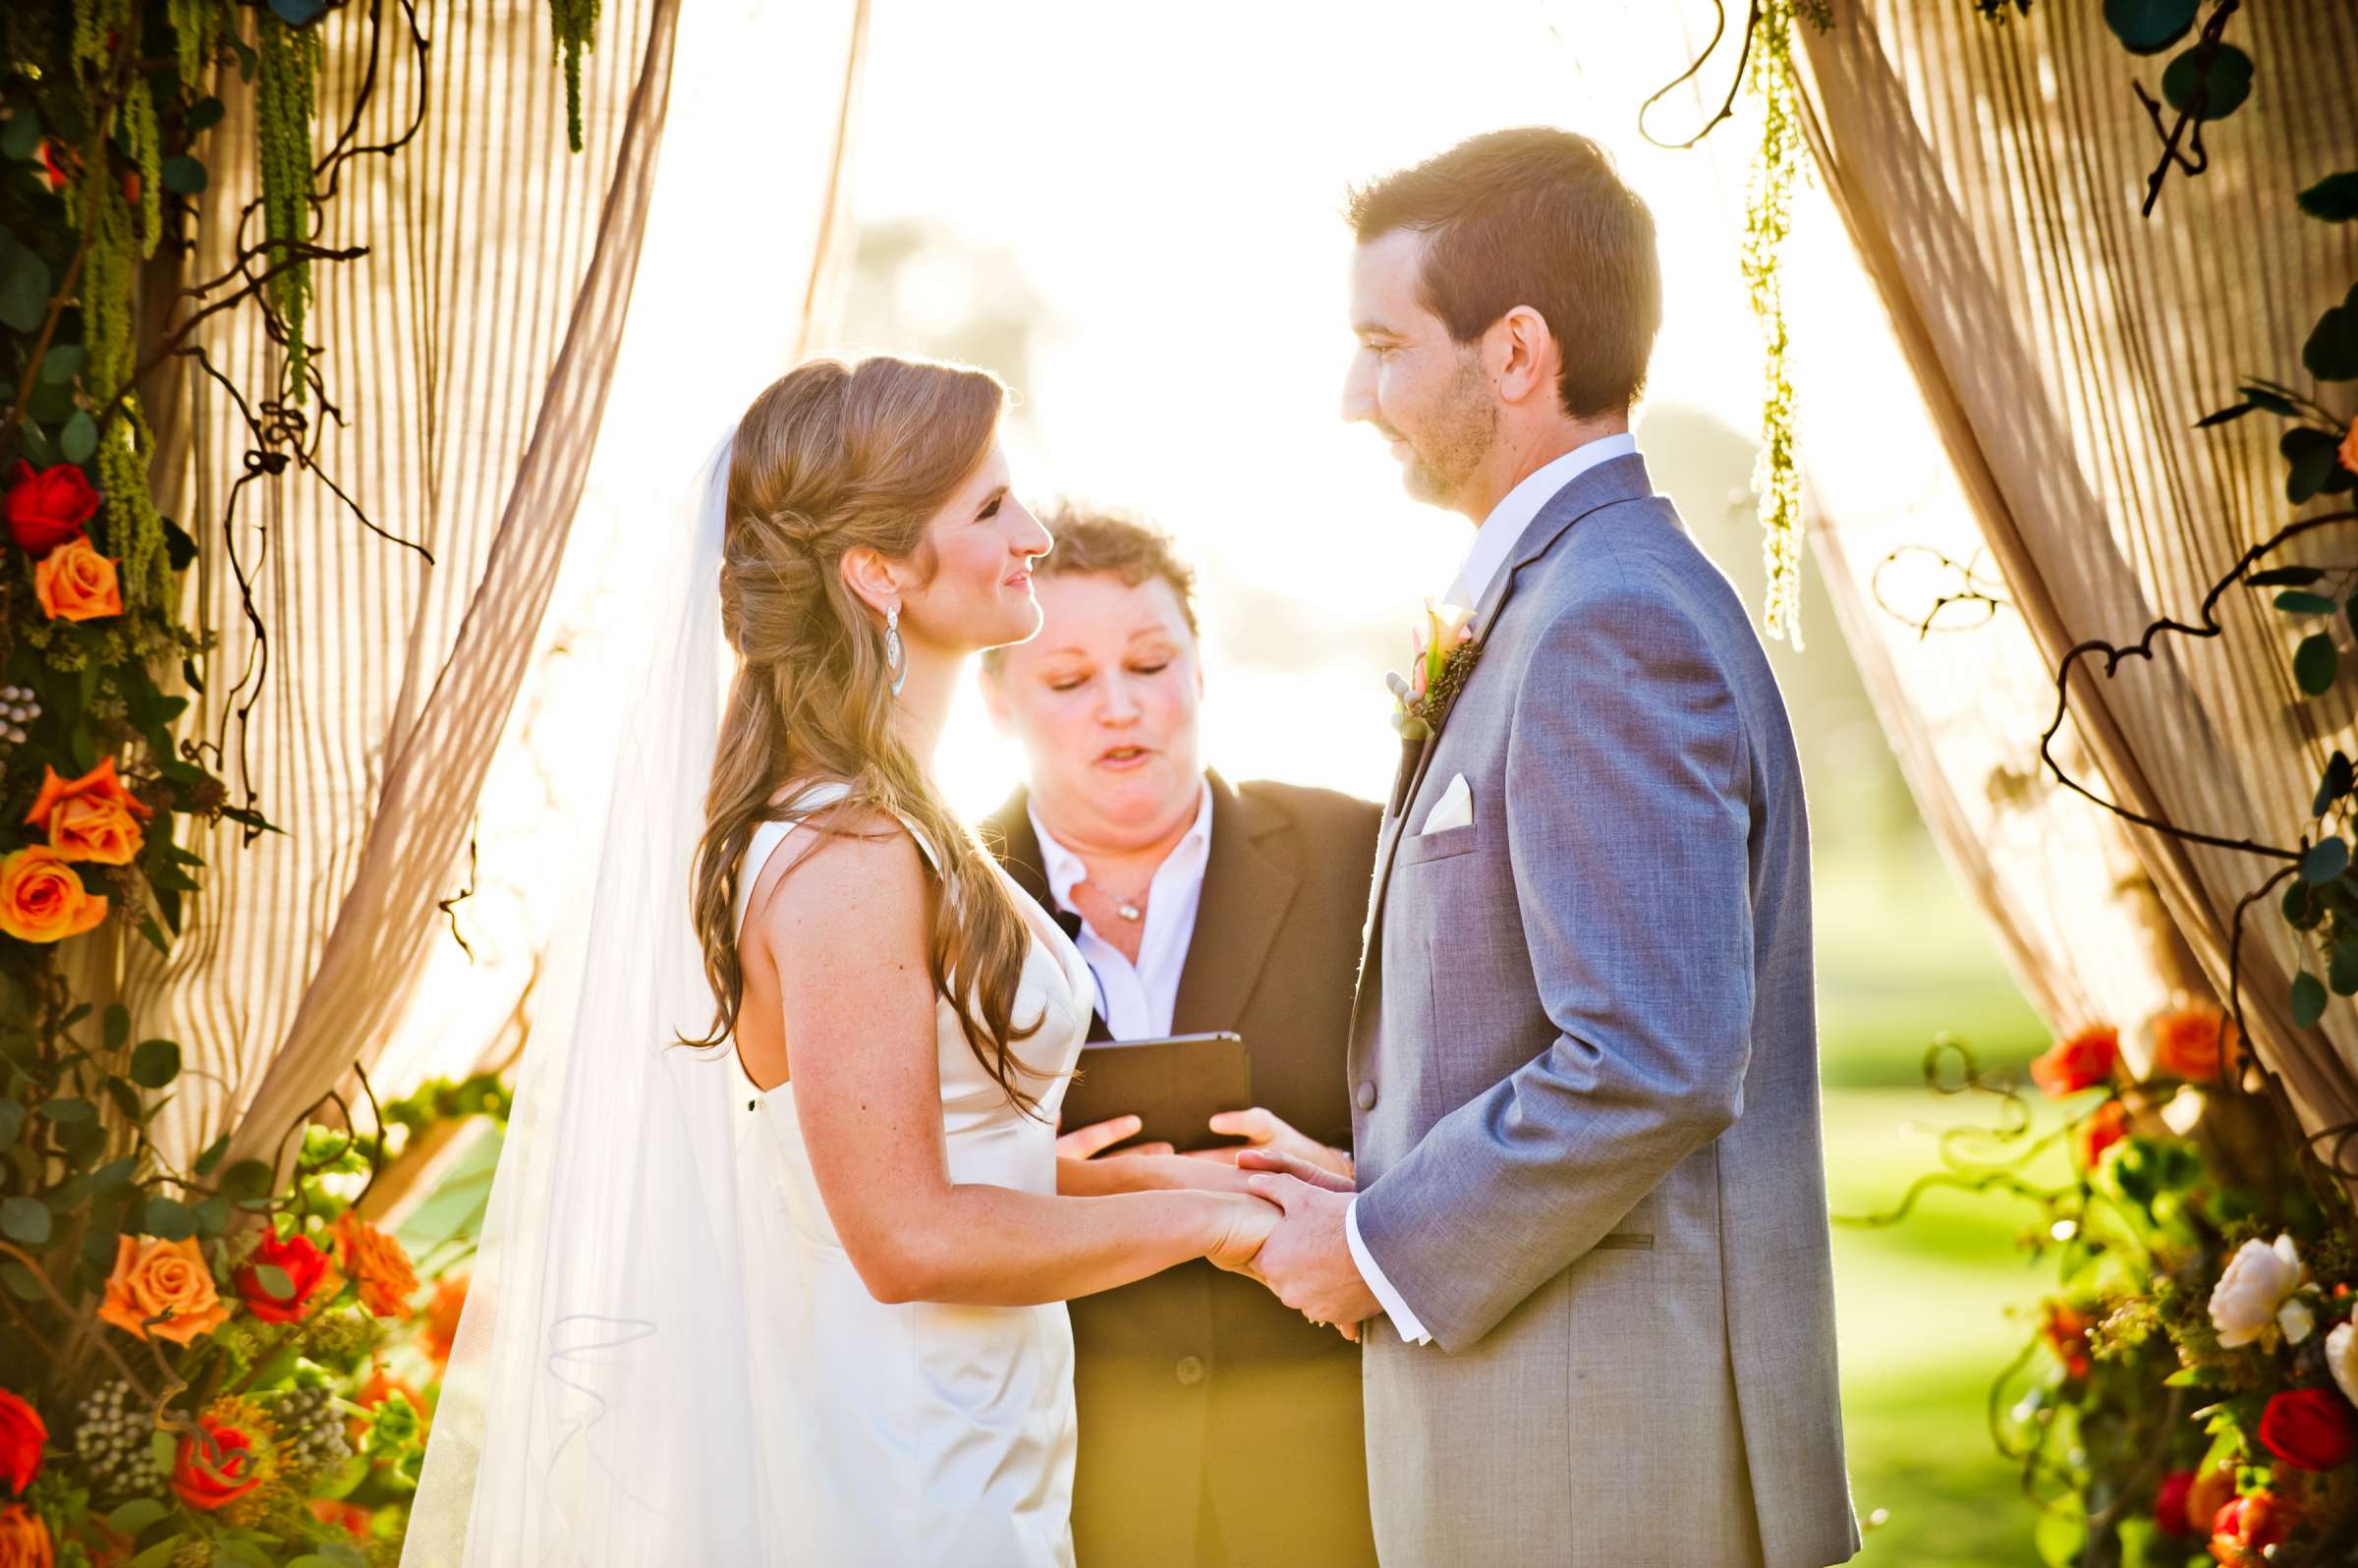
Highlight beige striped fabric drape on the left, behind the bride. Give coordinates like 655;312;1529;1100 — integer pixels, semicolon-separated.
128;0;677;1155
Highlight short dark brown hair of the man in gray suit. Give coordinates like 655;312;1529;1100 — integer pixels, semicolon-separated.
1346;125;1662;418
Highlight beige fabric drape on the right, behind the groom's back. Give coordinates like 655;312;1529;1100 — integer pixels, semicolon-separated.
1794;0;2358;1150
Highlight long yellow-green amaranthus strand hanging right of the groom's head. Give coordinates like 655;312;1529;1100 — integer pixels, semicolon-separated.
1743;0;1832;648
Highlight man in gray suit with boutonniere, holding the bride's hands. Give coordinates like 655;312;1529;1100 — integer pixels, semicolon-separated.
1248;130;1858;1568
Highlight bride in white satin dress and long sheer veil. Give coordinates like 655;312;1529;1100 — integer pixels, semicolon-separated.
403;359;1278;1568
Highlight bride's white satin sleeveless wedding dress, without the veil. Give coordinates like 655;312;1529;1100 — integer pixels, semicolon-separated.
714;792;1092;1568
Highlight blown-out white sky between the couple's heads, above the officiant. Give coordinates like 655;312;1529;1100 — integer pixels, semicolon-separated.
844;0;1759;812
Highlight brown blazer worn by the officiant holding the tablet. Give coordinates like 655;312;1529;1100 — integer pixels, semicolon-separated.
983;773;1377;1568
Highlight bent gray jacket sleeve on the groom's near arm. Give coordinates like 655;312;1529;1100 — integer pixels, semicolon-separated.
1358;585;1752;1351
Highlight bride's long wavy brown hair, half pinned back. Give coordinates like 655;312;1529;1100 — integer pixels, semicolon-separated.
689;356;1039;1113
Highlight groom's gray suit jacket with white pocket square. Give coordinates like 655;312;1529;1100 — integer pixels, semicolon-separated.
1351;455;1858;1568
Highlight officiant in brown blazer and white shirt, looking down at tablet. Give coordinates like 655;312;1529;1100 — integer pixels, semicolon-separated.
983;507;1377;1568
